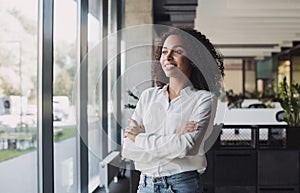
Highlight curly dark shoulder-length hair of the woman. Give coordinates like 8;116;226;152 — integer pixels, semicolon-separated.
152;27;224;92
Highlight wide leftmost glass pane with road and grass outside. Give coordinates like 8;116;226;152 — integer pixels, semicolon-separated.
0;0;38;193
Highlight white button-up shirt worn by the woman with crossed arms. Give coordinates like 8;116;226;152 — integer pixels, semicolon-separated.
122;86;216;177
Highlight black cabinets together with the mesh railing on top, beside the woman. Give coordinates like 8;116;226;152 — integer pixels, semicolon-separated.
203;125;300;193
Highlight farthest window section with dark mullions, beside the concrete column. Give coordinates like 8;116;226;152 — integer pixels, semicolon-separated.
85;0;117;190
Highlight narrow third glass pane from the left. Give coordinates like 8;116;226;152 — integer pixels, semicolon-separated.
86;0;101;192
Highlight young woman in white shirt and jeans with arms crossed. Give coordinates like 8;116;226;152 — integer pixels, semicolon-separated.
122;28;224;193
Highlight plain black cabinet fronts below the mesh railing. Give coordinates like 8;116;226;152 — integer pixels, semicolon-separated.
203;148;300;193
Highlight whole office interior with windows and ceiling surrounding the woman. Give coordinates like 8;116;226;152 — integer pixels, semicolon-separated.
0;0;300;193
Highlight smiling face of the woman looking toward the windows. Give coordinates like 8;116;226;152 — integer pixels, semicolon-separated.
160;35;191;79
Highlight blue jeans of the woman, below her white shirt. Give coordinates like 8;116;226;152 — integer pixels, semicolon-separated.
137;171;203;193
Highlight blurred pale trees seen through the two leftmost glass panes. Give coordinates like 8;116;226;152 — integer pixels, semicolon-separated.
0;8;76;103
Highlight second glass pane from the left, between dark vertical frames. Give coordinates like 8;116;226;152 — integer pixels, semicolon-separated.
53;0;78;193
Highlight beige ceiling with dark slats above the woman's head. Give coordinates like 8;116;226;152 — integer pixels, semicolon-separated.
154;0;300;59
